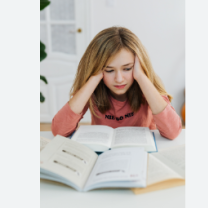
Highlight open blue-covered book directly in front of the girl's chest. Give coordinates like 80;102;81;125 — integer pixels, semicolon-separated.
72;125;157;152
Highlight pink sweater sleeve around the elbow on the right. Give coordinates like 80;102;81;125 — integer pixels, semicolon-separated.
153;96;182;140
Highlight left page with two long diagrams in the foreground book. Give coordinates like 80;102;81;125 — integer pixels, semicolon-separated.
40;135;98;189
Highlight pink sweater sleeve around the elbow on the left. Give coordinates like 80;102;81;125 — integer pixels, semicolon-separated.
51;102;88;137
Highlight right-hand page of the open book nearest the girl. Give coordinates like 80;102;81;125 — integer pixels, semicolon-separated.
112;127;155;150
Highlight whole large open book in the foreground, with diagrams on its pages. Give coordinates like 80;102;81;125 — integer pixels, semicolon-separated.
40;135;148;191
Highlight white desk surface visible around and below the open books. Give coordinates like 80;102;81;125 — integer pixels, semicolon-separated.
40;129;185;208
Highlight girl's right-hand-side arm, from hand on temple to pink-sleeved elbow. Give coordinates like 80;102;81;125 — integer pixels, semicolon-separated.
133;57;182;139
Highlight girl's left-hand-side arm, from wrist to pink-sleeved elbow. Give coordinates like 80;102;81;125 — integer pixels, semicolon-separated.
51;72;103;137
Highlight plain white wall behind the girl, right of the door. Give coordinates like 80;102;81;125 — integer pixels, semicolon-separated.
91;0;185;115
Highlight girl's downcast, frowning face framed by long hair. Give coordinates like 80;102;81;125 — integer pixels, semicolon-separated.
103;49;135;101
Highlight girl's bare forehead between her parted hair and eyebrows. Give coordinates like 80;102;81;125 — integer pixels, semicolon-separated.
106;48;134;66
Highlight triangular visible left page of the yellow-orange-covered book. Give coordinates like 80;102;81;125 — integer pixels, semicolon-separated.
147;154;181;186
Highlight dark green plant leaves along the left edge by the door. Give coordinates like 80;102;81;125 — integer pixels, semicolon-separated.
40;0;50;103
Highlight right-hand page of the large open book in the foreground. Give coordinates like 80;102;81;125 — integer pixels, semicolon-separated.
85;147;147;187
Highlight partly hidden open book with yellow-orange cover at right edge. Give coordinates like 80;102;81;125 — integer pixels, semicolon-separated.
132;145;185;194
